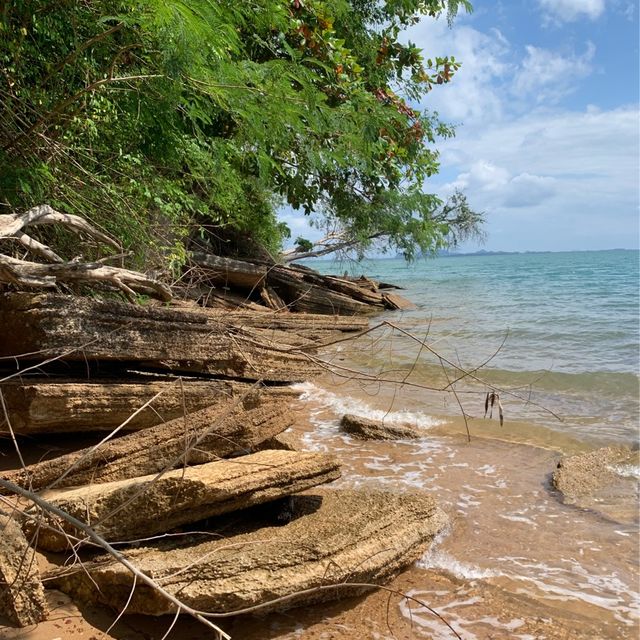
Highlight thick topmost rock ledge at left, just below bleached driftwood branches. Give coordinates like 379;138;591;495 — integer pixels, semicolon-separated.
0;294;319;382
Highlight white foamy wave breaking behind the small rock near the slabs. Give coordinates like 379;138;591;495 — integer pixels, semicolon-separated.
293;382;443;429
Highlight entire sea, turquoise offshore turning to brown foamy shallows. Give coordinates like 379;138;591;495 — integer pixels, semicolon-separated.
230;250;640;640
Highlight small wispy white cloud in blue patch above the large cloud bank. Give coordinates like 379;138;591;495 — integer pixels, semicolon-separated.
512;42;595;104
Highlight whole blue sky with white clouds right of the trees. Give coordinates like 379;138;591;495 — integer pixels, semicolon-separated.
283;0;640;251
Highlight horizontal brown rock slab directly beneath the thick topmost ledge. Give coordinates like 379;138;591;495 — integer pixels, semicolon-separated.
0;378;297;435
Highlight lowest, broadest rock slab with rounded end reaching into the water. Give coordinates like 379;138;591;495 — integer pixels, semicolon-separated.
53;489;447;615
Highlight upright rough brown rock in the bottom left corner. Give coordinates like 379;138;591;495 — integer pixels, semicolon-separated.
0;515;48;627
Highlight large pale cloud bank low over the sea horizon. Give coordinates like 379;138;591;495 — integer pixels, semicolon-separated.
432;106;640;250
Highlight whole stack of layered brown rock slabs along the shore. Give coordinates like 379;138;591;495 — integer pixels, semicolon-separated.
0;292;446;622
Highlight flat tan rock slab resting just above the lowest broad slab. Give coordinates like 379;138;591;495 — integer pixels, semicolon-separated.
26;451;340;551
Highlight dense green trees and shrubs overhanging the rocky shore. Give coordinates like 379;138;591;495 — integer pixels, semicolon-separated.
0;0;481;269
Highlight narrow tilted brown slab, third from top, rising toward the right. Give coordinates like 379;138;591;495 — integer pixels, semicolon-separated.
0;399;295;491
